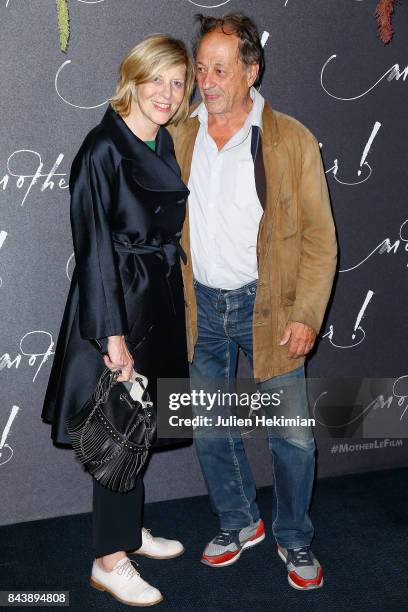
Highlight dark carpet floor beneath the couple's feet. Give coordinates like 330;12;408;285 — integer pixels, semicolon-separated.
0;469;408;612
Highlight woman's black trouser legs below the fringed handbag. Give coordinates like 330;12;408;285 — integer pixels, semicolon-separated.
92;476;144;557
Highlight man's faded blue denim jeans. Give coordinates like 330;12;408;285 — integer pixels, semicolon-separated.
190;281;315;548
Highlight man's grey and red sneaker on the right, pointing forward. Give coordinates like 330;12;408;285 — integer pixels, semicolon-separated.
278;546;323;591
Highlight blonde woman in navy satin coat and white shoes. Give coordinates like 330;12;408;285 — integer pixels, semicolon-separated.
42;34;194;605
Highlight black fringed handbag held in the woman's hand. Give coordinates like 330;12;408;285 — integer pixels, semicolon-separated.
67;368;156;493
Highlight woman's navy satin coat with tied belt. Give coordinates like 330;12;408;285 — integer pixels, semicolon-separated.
42;107;188;444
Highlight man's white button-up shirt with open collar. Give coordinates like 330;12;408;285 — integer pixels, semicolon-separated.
188;88;264;289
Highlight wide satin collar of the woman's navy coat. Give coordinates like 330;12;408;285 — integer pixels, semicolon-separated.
101;105;188;192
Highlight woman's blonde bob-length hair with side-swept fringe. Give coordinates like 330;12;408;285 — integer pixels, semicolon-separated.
109;34;195;125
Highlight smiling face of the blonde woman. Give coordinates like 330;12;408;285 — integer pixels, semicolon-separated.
134;65;186;129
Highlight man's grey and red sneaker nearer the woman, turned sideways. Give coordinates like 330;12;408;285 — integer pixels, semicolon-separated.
201;519;265;567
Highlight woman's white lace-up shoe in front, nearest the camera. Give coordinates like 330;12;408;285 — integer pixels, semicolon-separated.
90;557;163;606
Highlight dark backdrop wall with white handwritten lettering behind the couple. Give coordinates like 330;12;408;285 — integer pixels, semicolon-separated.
0;0;408;524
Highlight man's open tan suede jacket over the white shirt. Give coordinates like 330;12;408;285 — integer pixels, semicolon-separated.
170;102;337;380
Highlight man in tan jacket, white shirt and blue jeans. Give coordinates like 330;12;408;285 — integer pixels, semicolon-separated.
173;13;337;589
